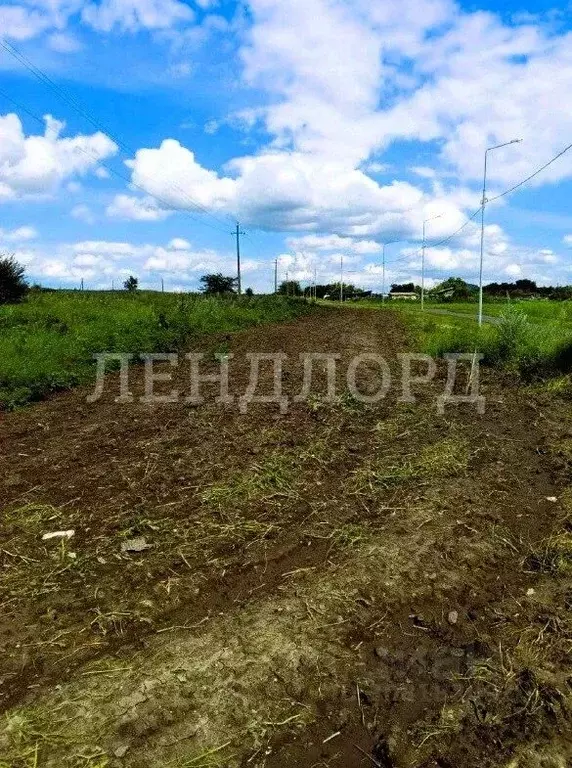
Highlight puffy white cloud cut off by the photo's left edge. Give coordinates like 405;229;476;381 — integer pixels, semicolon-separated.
0;114;117;202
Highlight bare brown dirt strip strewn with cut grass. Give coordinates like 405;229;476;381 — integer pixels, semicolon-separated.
0;309;572;768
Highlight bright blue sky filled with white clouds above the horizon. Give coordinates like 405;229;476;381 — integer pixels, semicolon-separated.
0;0;572;291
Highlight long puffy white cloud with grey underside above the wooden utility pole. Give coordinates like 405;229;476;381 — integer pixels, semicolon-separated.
124;139;438;235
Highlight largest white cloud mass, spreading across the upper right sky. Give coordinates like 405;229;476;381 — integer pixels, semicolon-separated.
241;0;572;190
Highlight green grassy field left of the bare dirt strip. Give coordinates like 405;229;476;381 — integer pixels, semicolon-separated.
0;291;307;409
